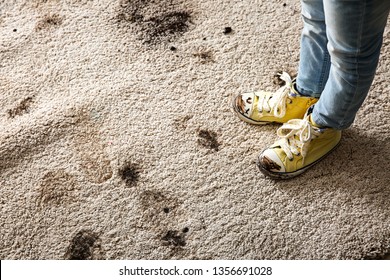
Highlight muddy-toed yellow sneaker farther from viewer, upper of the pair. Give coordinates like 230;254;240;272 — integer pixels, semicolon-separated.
232;72;318;124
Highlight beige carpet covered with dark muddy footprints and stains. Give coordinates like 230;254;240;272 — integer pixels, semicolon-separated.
0;0;390;259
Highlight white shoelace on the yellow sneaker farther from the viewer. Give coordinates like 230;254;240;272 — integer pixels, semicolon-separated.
255;72;292;118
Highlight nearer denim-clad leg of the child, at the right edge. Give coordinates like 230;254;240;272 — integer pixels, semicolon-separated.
312;0;390;129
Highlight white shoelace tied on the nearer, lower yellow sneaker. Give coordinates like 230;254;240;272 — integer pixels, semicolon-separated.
277;117;321;160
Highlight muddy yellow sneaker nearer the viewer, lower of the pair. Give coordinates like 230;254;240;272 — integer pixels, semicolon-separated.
257;109;341;179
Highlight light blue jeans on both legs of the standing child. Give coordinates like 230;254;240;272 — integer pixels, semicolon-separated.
297;0;390;130
